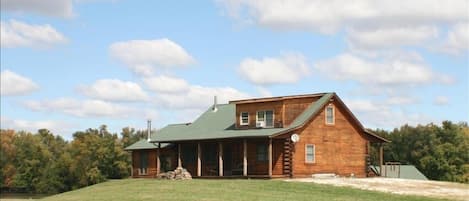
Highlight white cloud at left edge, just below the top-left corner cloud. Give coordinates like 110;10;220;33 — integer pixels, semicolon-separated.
0;20;67;48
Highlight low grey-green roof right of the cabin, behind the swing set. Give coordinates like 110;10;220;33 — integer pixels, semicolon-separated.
374;165;428;180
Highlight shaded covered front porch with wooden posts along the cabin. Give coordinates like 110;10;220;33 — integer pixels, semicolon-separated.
156;138;292;178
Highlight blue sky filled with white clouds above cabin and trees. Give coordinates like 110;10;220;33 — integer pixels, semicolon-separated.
1;0;469;138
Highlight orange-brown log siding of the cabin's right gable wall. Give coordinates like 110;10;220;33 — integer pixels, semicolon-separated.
293;101;367;177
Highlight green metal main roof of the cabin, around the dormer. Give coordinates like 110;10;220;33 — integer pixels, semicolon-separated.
151;93;334;142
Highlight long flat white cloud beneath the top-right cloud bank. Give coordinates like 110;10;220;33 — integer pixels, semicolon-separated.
347;26;438;50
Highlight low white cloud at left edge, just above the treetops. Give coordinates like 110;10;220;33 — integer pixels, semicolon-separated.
0;116;74;138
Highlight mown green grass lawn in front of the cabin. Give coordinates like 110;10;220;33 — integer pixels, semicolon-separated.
42;179;450;201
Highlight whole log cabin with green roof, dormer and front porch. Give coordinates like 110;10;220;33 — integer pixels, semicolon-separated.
126;93;388;178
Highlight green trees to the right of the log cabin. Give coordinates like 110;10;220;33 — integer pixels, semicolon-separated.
372;121;469;183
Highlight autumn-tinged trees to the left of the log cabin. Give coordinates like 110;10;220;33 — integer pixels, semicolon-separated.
0;125;146;194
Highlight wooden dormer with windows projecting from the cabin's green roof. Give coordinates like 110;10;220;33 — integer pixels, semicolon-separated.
230;94;324;129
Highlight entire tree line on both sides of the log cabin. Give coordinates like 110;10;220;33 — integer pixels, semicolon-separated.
0;121;469;194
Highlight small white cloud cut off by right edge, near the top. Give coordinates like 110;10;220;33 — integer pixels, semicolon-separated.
442;23;469;54
